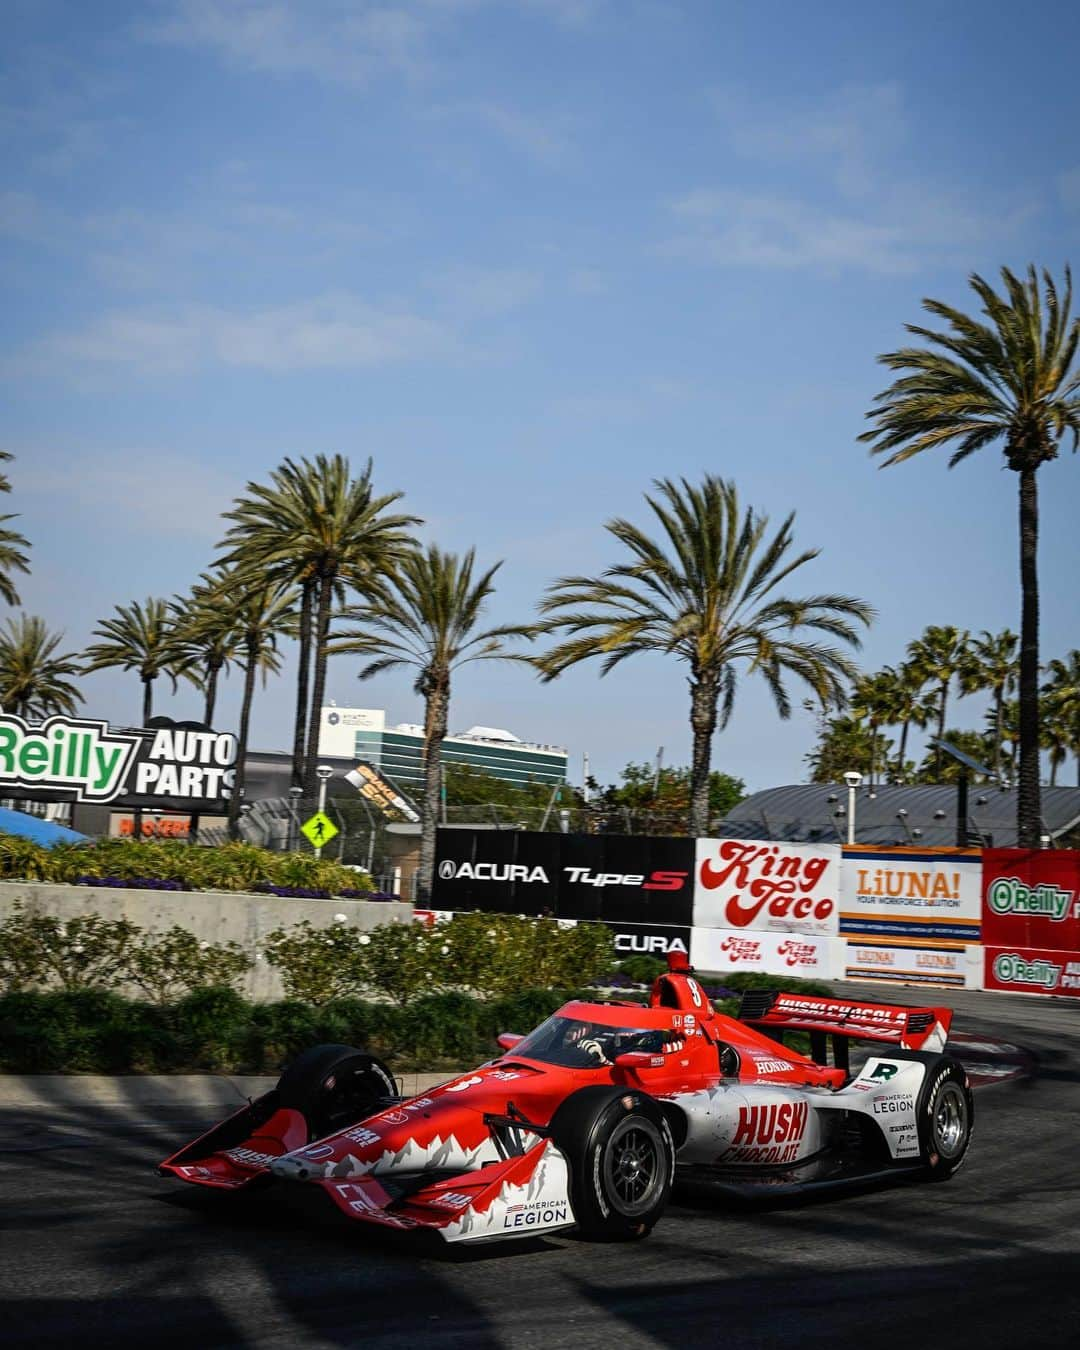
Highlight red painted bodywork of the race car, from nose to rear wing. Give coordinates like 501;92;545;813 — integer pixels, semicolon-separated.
159;968;952;1229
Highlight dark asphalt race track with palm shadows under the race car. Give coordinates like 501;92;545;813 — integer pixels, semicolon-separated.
0;986;1080;1350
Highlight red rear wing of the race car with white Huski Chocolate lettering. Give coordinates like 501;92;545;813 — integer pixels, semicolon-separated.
738;990;953;1068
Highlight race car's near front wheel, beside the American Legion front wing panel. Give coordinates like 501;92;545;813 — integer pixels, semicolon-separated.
549;1084;675;1242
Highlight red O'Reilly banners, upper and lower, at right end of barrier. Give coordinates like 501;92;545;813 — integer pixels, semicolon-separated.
983;849;1080;998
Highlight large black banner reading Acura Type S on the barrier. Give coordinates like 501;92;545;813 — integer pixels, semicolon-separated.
432;830;694;936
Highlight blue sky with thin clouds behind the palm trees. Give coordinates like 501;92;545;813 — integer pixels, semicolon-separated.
0;0;1080;788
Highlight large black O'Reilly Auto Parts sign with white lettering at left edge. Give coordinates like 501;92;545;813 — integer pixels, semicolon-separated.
0;714;236;811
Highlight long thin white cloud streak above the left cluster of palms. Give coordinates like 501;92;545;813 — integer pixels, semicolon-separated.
15;296;455;374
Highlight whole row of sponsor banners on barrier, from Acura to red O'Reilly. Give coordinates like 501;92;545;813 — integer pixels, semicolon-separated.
431;829;1080;996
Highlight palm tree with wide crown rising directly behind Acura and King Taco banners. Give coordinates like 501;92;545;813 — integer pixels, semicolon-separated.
536;475;873;834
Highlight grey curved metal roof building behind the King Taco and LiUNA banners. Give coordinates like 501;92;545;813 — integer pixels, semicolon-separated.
711;783;1080;848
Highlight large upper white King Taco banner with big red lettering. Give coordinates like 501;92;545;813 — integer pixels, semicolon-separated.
694;840;841;937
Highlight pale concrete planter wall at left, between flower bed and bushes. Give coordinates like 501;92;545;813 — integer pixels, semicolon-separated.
0;882;413;1002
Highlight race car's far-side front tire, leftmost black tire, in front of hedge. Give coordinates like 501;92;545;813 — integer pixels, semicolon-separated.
277;1045;397;1139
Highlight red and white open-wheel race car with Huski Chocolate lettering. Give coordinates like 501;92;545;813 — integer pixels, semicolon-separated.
159;957;973;1242
